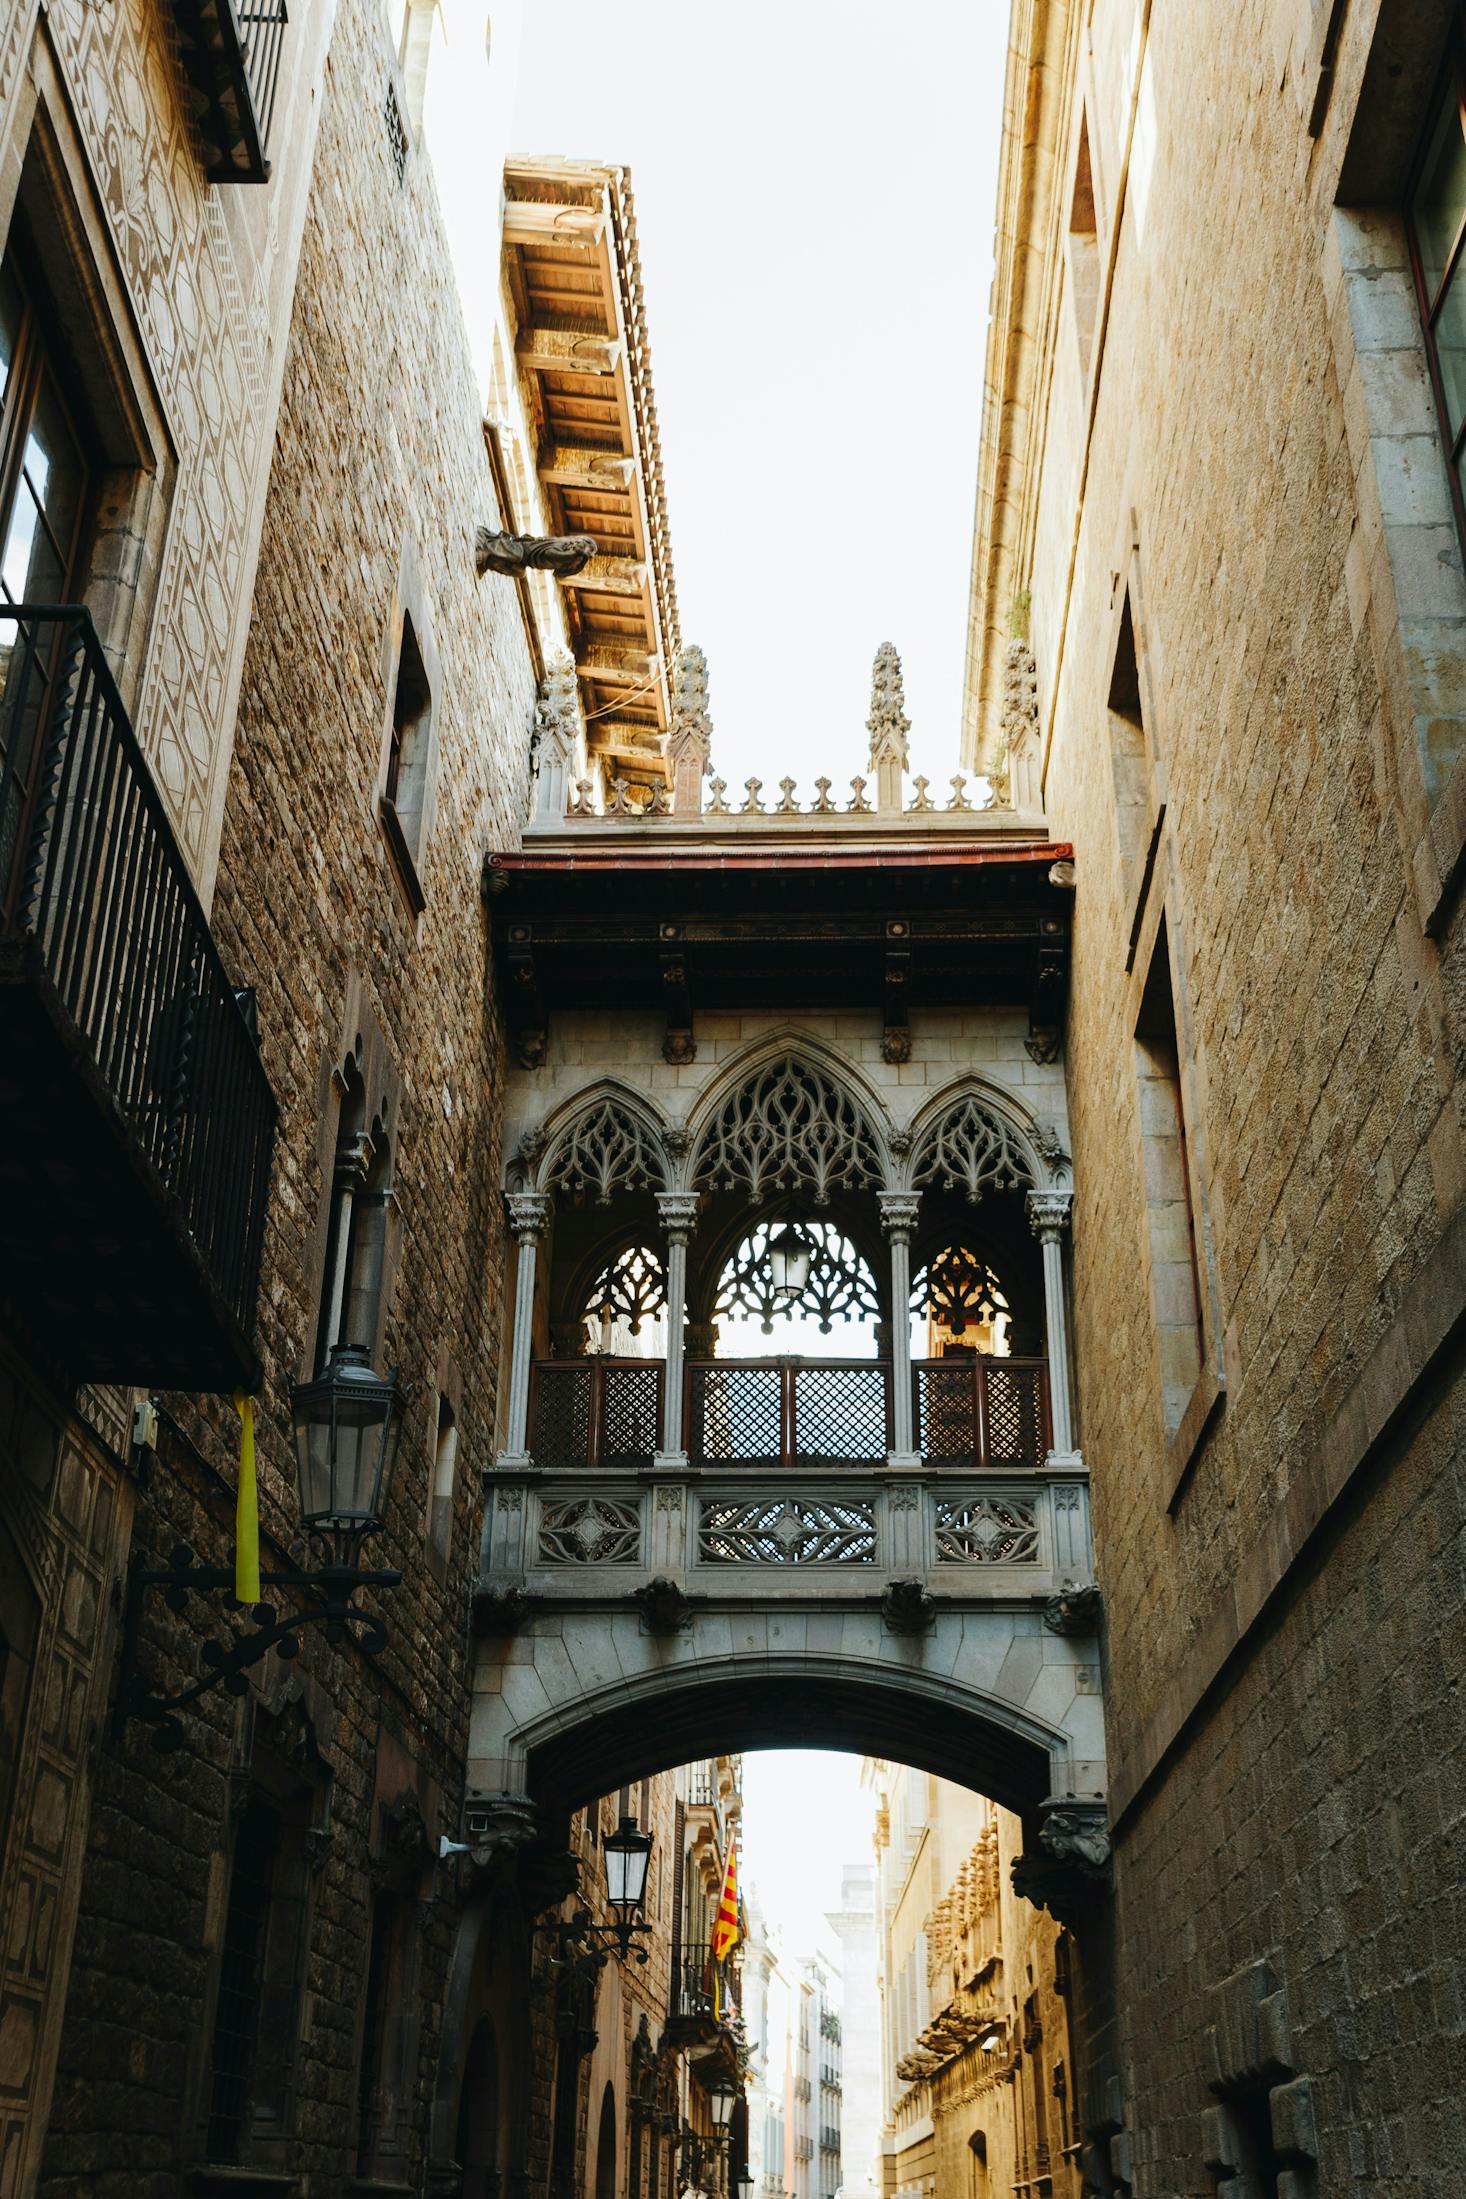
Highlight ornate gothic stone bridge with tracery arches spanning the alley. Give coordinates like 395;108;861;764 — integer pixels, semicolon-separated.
470;642;1106;1896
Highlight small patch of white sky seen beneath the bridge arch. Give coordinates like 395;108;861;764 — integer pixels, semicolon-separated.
743;1748;875;1957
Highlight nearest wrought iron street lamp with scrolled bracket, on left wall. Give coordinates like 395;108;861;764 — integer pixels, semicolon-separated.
116;1346;407;1753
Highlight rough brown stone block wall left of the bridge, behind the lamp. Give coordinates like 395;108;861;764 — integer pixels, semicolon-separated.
40;0;534;2199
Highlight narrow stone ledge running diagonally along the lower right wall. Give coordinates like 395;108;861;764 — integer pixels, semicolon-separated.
1110;1205;1466;1832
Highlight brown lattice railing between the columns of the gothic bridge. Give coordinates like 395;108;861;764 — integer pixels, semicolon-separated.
530;1355;1051;1473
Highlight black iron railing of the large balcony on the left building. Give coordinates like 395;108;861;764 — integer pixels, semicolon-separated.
0;605;275;1337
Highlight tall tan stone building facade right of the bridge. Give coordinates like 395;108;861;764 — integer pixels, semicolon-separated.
967;0;1466;2192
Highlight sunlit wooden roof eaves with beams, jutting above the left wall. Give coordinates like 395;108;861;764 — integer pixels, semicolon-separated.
503;161;681;783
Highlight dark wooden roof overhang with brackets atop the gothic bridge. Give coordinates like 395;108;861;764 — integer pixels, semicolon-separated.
486;833;1073;1064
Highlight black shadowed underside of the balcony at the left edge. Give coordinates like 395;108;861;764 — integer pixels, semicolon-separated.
0;939;257;1390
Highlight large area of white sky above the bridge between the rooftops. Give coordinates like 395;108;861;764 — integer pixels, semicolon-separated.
512;0;1009;800
